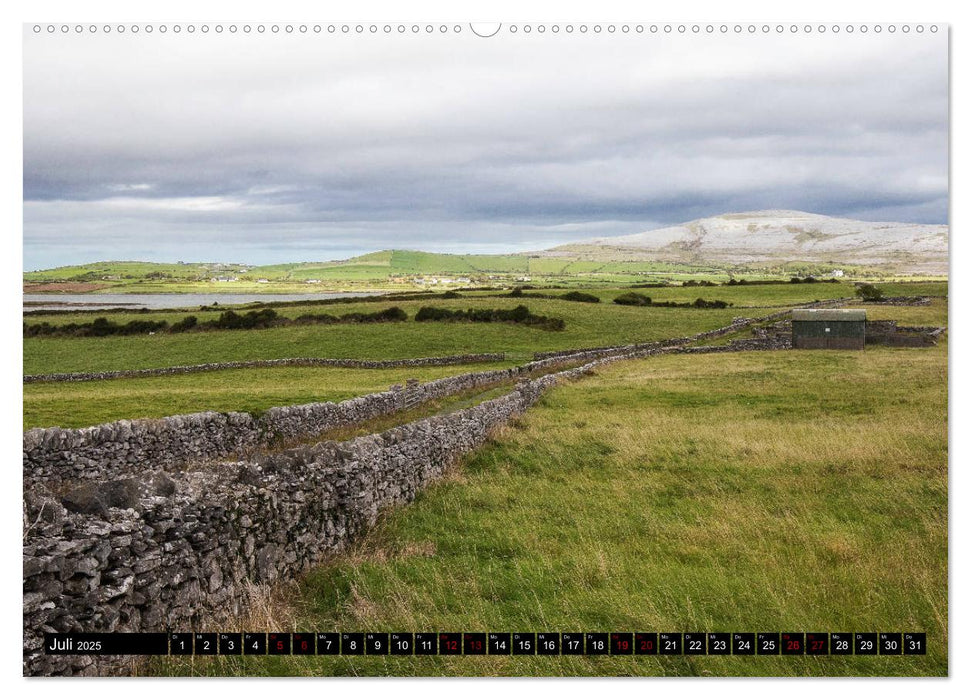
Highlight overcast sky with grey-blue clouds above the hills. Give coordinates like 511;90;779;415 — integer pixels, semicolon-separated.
24;28;948;269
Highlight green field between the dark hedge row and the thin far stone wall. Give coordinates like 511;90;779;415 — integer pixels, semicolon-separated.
24;299;738;374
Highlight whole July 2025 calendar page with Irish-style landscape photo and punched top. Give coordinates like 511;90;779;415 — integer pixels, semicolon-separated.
21;19;950;678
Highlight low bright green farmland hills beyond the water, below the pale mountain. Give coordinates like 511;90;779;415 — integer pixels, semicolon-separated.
23;254;940;293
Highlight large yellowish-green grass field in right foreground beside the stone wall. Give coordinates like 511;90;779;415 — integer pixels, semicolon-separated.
152;336;948;676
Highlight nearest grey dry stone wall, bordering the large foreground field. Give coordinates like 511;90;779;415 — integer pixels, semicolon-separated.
23;358;621;675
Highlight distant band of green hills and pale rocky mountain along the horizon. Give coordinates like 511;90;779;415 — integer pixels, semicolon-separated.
23;210;949;292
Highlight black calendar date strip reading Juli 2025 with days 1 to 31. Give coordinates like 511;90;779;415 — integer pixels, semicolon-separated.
44;632;927;656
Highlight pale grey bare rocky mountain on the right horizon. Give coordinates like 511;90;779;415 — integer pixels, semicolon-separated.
545;210;949;274
